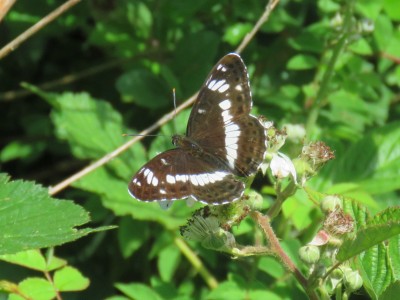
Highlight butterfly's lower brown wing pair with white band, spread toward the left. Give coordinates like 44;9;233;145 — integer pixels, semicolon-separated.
128;148;245;204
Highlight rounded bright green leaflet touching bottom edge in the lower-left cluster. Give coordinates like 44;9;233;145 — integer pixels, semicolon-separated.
8;278;56;300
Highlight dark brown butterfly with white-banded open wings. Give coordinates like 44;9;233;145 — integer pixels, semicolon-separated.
128;53;267;205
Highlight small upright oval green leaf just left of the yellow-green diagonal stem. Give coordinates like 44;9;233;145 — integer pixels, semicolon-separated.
157;244;181;282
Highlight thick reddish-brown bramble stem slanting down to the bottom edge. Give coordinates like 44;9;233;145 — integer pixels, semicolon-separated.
250;211;318;300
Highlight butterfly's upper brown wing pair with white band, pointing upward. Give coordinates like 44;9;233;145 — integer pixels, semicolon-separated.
187;53;266;177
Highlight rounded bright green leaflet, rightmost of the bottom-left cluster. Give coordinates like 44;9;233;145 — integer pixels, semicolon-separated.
53;266;90;292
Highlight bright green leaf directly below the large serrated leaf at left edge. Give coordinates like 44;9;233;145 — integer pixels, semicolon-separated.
0;249;67;272
